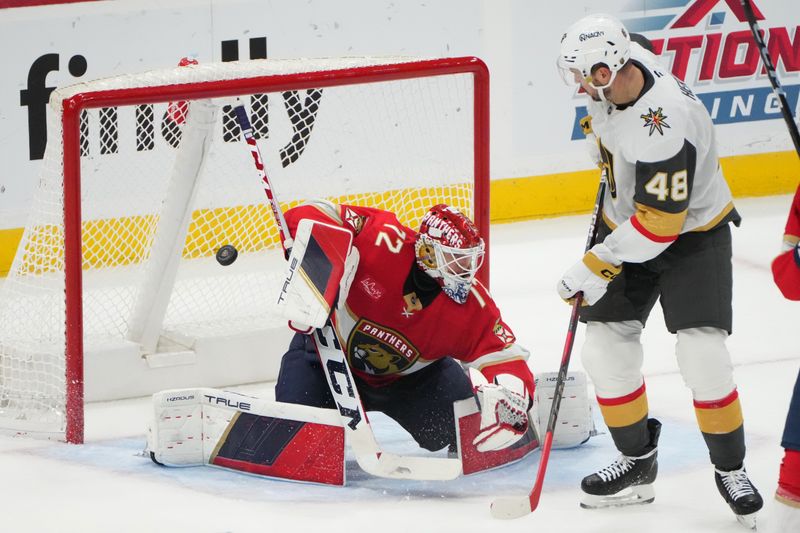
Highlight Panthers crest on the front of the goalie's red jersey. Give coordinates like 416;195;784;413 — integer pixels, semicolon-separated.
347;318;419;376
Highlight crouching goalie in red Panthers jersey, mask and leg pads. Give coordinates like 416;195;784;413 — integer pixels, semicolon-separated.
149;200;591;484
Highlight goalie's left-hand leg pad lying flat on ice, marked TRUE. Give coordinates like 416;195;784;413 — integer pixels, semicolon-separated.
147;388;345;485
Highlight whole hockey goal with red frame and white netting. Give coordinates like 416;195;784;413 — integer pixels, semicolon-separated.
0;57;489;443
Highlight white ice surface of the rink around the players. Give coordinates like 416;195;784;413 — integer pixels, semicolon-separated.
0;196;800;533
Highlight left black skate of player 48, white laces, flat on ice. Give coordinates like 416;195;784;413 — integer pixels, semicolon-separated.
581;418;661;509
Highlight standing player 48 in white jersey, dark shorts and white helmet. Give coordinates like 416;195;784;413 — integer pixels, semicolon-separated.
558;15;762;527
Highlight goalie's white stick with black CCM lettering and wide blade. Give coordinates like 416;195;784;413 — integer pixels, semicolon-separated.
233;103;461;480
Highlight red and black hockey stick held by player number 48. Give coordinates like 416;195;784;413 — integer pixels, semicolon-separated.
491;169;606;519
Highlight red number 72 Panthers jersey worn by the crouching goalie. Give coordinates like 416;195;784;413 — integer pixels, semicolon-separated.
286;202;533;394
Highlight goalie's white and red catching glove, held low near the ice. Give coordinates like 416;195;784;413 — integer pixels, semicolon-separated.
469;368;530;452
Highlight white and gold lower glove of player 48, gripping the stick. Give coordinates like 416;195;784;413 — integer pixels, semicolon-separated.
557;243;622;305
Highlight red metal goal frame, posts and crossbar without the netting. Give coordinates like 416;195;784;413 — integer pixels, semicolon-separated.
61;57;490;444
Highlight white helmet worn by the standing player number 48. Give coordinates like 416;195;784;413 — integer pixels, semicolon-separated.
556;14;631;94
